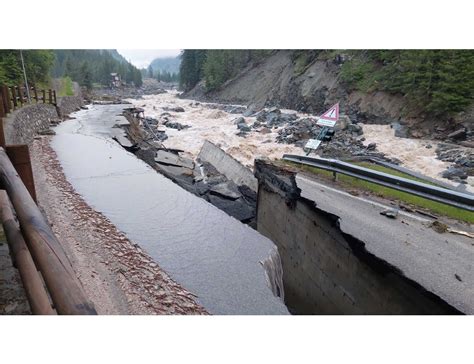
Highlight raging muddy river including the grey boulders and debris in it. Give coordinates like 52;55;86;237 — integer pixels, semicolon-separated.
127;92;474;192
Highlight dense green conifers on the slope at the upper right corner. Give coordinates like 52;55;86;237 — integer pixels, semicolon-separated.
341;50;474;116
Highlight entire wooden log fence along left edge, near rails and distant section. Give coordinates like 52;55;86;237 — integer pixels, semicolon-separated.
0;86;96;315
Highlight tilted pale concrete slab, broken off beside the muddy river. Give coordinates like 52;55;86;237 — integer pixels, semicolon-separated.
198;140;258;191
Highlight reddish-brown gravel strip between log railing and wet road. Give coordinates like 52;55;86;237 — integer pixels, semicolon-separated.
30;136;206;314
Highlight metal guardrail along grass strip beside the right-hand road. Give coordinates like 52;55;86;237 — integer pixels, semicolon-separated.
283;154;474;211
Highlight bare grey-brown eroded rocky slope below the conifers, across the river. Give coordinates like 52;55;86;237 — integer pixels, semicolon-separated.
186;50;474;140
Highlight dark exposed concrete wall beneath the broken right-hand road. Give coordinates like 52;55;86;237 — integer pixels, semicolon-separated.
256;161;455;314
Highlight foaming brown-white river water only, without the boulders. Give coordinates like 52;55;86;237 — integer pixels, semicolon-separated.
128;91;474;192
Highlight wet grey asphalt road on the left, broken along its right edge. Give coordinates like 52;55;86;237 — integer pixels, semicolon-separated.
52;105;288;314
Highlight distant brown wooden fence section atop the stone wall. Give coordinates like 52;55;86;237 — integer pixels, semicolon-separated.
0;85;57;118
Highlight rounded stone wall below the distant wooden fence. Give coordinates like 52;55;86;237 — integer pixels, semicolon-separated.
3;104;58;144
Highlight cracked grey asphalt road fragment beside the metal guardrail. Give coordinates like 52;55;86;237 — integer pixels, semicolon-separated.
296;174;474;314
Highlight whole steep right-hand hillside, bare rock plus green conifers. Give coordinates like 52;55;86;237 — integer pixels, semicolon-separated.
181;50;474;139
